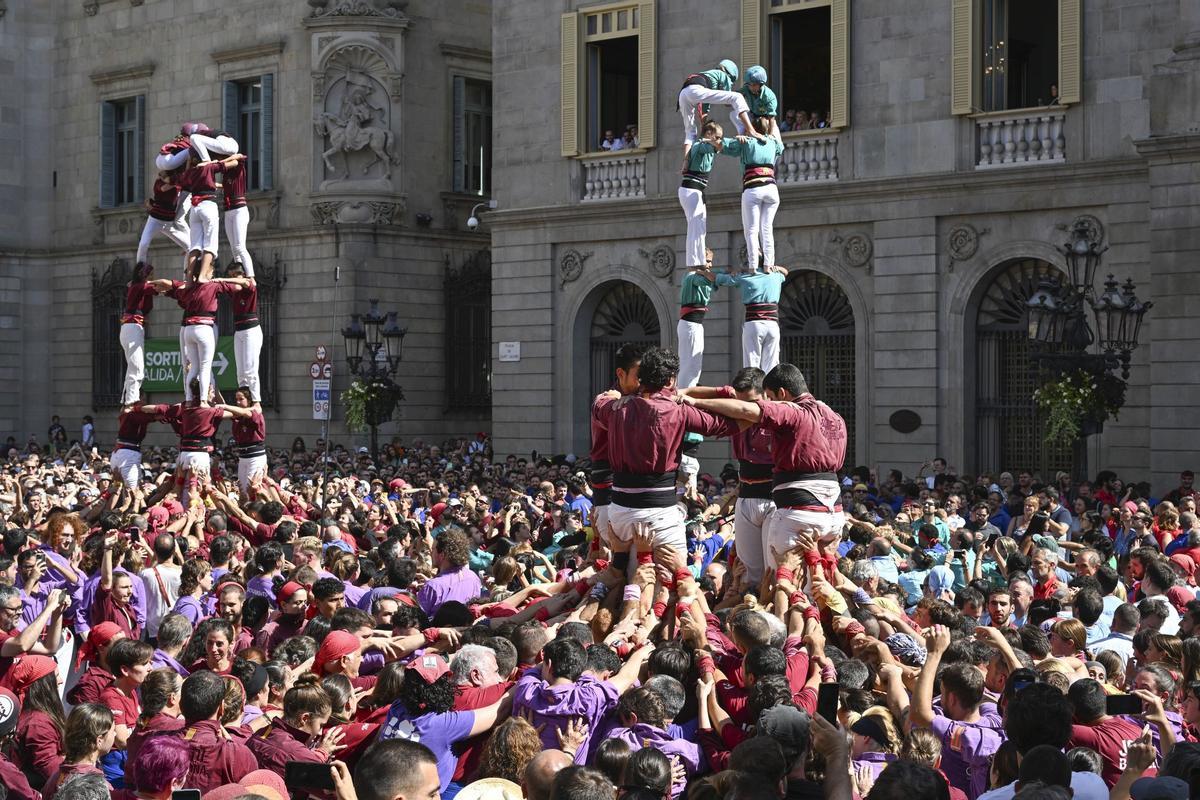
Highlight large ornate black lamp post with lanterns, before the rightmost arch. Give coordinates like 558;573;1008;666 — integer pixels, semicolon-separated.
1026;219;1154;480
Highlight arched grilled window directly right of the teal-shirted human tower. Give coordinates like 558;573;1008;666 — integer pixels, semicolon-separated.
779;270;857;459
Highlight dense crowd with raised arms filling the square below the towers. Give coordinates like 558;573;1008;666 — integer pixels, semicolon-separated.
0;434;1200;800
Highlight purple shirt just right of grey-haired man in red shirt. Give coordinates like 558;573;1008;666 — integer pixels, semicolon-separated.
512;667;620;765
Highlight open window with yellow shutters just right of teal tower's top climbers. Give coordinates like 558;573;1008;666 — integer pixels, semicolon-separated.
763;0;850;131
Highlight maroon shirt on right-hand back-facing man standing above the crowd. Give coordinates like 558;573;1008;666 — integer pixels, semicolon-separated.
758;395;846;474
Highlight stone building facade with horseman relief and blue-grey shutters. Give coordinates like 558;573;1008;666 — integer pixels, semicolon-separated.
0;0;492;447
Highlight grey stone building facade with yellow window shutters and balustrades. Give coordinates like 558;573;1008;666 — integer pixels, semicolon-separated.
490;0;1200;491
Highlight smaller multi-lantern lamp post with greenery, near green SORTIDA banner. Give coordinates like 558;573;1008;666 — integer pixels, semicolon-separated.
342;300;408;459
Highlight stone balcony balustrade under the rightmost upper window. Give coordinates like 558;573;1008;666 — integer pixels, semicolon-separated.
974;108;1067;169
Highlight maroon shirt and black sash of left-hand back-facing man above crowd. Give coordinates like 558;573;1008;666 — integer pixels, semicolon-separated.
594;390;738;507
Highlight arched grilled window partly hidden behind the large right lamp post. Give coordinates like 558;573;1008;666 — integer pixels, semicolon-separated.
974;258;1072;479
